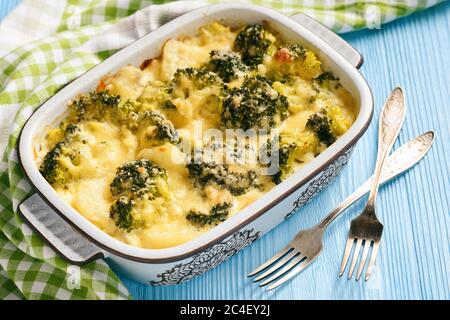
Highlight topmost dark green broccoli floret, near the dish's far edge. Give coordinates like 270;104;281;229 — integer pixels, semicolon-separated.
234;24;274;67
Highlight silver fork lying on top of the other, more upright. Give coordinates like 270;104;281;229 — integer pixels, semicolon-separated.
339;87;406;281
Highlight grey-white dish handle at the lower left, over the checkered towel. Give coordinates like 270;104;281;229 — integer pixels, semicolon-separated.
19;193;104;265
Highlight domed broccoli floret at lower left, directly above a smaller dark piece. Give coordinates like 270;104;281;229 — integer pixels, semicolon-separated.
110;159;167;200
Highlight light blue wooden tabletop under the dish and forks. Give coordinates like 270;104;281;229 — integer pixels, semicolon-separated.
0;0;450;299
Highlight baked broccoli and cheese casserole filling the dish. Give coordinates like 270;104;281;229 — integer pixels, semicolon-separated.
36;22;357;248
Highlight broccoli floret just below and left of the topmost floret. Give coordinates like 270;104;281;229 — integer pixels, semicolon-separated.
207;50;248;82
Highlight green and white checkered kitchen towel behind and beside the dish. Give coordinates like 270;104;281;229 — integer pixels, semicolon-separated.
0;0;439;299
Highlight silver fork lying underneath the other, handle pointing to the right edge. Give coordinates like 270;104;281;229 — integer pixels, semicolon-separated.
248;89;428;290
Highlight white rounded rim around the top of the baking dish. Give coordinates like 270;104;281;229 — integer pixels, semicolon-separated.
18;3;373;263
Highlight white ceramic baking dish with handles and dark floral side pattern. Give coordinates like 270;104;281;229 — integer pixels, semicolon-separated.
19;3;373;285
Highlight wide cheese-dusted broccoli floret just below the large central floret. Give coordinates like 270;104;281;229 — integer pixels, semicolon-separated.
186;160;259;196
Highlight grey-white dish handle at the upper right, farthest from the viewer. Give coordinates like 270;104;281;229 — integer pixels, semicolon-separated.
290;13;364;69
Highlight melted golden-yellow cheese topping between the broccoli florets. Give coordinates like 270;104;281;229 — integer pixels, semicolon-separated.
36;23;356;248
